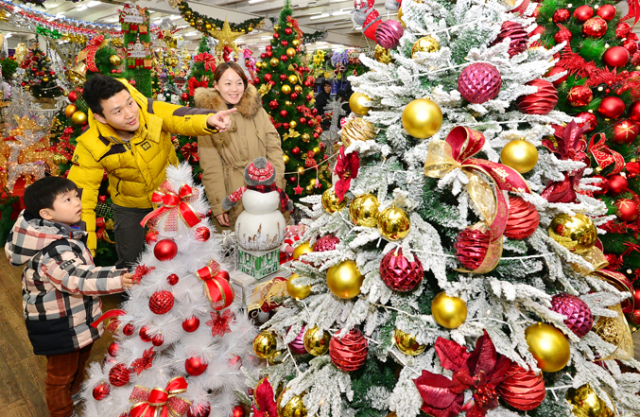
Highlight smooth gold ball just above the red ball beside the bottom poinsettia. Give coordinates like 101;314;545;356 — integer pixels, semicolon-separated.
524;323;571;372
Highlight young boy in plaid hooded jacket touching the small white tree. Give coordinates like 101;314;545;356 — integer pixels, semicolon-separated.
5;177;133;417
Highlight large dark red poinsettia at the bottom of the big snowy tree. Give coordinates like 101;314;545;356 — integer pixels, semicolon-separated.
413;330;511;417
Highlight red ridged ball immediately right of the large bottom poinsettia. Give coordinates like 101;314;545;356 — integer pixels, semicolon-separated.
496;362;547;411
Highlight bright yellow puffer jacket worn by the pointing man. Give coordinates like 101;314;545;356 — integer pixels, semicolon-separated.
69;80;216;253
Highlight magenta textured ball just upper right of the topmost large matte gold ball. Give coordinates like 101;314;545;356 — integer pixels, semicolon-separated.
458;63;502;103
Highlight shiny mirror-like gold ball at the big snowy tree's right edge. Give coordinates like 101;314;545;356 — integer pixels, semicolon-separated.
549;213;598;255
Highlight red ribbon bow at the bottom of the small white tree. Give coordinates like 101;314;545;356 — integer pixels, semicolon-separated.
129;376;191;417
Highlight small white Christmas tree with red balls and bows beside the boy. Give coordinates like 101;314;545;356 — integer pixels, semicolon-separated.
82;163;255;417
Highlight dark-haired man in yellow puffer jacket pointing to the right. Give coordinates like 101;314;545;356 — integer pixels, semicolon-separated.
69;75;236;267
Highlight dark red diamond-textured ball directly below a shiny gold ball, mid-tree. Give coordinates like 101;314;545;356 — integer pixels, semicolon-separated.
380;249;424;292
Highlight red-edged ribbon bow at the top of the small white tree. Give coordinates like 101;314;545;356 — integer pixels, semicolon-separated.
140;181;200;232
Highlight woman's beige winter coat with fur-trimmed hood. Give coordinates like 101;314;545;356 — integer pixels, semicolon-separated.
195;85;285;228
